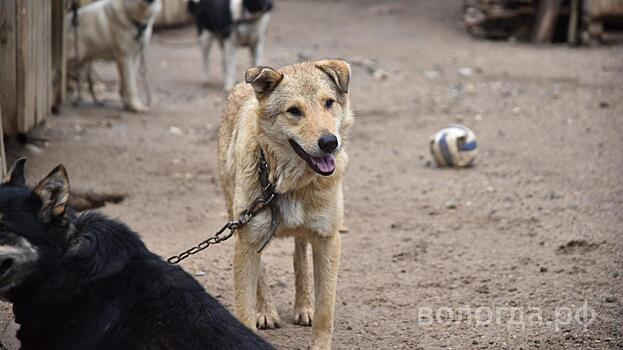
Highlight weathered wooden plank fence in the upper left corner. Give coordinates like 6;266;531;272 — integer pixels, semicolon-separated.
0;0;65;135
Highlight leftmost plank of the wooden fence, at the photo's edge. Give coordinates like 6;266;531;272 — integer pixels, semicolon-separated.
0;0;17;135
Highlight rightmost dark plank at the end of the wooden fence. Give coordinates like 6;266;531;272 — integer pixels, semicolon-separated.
51;0;67;105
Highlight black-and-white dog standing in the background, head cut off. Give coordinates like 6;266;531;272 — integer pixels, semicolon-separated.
188;0;273;91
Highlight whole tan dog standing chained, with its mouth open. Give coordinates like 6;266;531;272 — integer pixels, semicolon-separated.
218;60;353;349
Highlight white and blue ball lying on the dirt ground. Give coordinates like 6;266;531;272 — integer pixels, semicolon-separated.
430;124;478;168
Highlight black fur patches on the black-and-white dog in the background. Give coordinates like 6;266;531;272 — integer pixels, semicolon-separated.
188;0;273;38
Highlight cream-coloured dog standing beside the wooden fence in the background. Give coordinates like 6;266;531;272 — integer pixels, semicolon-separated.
65;0;162;112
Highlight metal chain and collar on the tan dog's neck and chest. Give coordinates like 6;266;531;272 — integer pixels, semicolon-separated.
167;149;279;265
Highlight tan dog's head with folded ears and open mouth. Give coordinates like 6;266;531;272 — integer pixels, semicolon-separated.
245;60;353;176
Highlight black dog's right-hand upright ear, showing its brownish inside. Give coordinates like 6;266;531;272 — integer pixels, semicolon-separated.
34;165;69;220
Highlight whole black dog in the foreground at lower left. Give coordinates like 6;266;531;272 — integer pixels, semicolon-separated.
0;159;273;350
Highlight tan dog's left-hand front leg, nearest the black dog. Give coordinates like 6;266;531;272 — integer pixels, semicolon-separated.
234;229;260;330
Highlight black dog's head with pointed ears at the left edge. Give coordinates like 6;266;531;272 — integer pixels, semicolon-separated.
0;159;70;299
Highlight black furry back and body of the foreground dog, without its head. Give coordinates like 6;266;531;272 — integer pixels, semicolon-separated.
14;214;273;350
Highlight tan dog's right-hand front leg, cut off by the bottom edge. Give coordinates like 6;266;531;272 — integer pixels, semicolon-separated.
311;232;340;350
